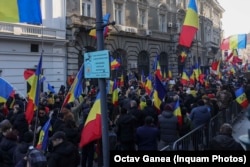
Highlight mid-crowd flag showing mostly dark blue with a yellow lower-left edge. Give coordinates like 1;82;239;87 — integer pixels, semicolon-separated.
153;76;167;114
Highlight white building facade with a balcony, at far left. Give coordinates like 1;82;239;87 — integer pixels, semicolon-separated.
0;0;67;94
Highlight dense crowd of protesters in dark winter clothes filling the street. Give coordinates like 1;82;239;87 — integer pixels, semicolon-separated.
0;70;250;167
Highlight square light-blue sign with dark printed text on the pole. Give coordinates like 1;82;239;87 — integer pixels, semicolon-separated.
84;50;110;78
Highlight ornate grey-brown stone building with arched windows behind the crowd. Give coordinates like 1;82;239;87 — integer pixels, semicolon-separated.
66;0;224;78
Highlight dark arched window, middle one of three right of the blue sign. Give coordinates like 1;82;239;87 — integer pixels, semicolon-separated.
138;51;150;76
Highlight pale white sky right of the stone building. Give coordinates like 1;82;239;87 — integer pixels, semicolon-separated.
218;0;250;37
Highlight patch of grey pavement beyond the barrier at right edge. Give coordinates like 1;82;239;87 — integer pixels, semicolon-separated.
232;110;250;148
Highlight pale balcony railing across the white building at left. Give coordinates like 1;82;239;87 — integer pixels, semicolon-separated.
0;22;65;39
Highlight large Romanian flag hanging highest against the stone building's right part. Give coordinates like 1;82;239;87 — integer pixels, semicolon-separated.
179;0;199;47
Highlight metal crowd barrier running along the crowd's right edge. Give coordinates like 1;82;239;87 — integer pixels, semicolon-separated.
160;101;242;151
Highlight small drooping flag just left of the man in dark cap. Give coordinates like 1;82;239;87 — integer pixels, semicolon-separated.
36;119;51;151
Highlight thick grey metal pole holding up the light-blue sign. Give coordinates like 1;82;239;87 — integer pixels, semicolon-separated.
96;0;109;167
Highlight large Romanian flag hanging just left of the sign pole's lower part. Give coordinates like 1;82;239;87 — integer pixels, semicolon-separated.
79;93;102;147
